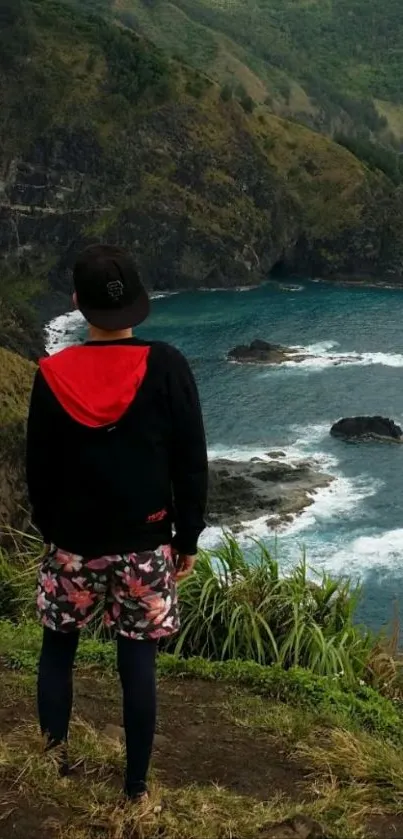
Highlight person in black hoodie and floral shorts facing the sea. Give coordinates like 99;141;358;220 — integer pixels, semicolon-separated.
27;245;208;800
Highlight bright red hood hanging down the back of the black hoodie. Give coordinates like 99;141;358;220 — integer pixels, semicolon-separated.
40;344;150;428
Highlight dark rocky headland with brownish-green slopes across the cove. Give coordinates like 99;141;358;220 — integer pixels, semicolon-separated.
0;0;403;358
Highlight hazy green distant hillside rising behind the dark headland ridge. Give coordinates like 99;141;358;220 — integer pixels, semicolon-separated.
110;0;403;137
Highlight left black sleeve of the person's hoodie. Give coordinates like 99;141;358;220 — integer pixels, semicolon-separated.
26;370;51;543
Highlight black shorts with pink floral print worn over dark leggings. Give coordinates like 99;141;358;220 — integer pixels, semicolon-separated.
37;545;179;640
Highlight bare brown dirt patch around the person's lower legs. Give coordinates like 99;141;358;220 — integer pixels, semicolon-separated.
0;675;304;804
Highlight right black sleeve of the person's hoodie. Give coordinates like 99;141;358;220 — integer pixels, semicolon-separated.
168;351;208;556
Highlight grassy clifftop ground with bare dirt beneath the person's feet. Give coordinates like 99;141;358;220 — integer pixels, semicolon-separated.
0;624;403;839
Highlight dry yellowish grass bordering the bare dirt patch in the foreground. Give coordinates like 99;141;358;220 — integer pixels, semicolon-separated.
0;673;403;839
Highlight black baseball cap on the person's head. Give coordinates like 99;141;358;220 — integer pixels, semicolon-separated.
73;245;150;331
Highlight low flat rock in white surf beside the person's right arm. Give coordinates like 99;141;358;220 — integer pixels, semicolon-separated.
208;459;333;528
